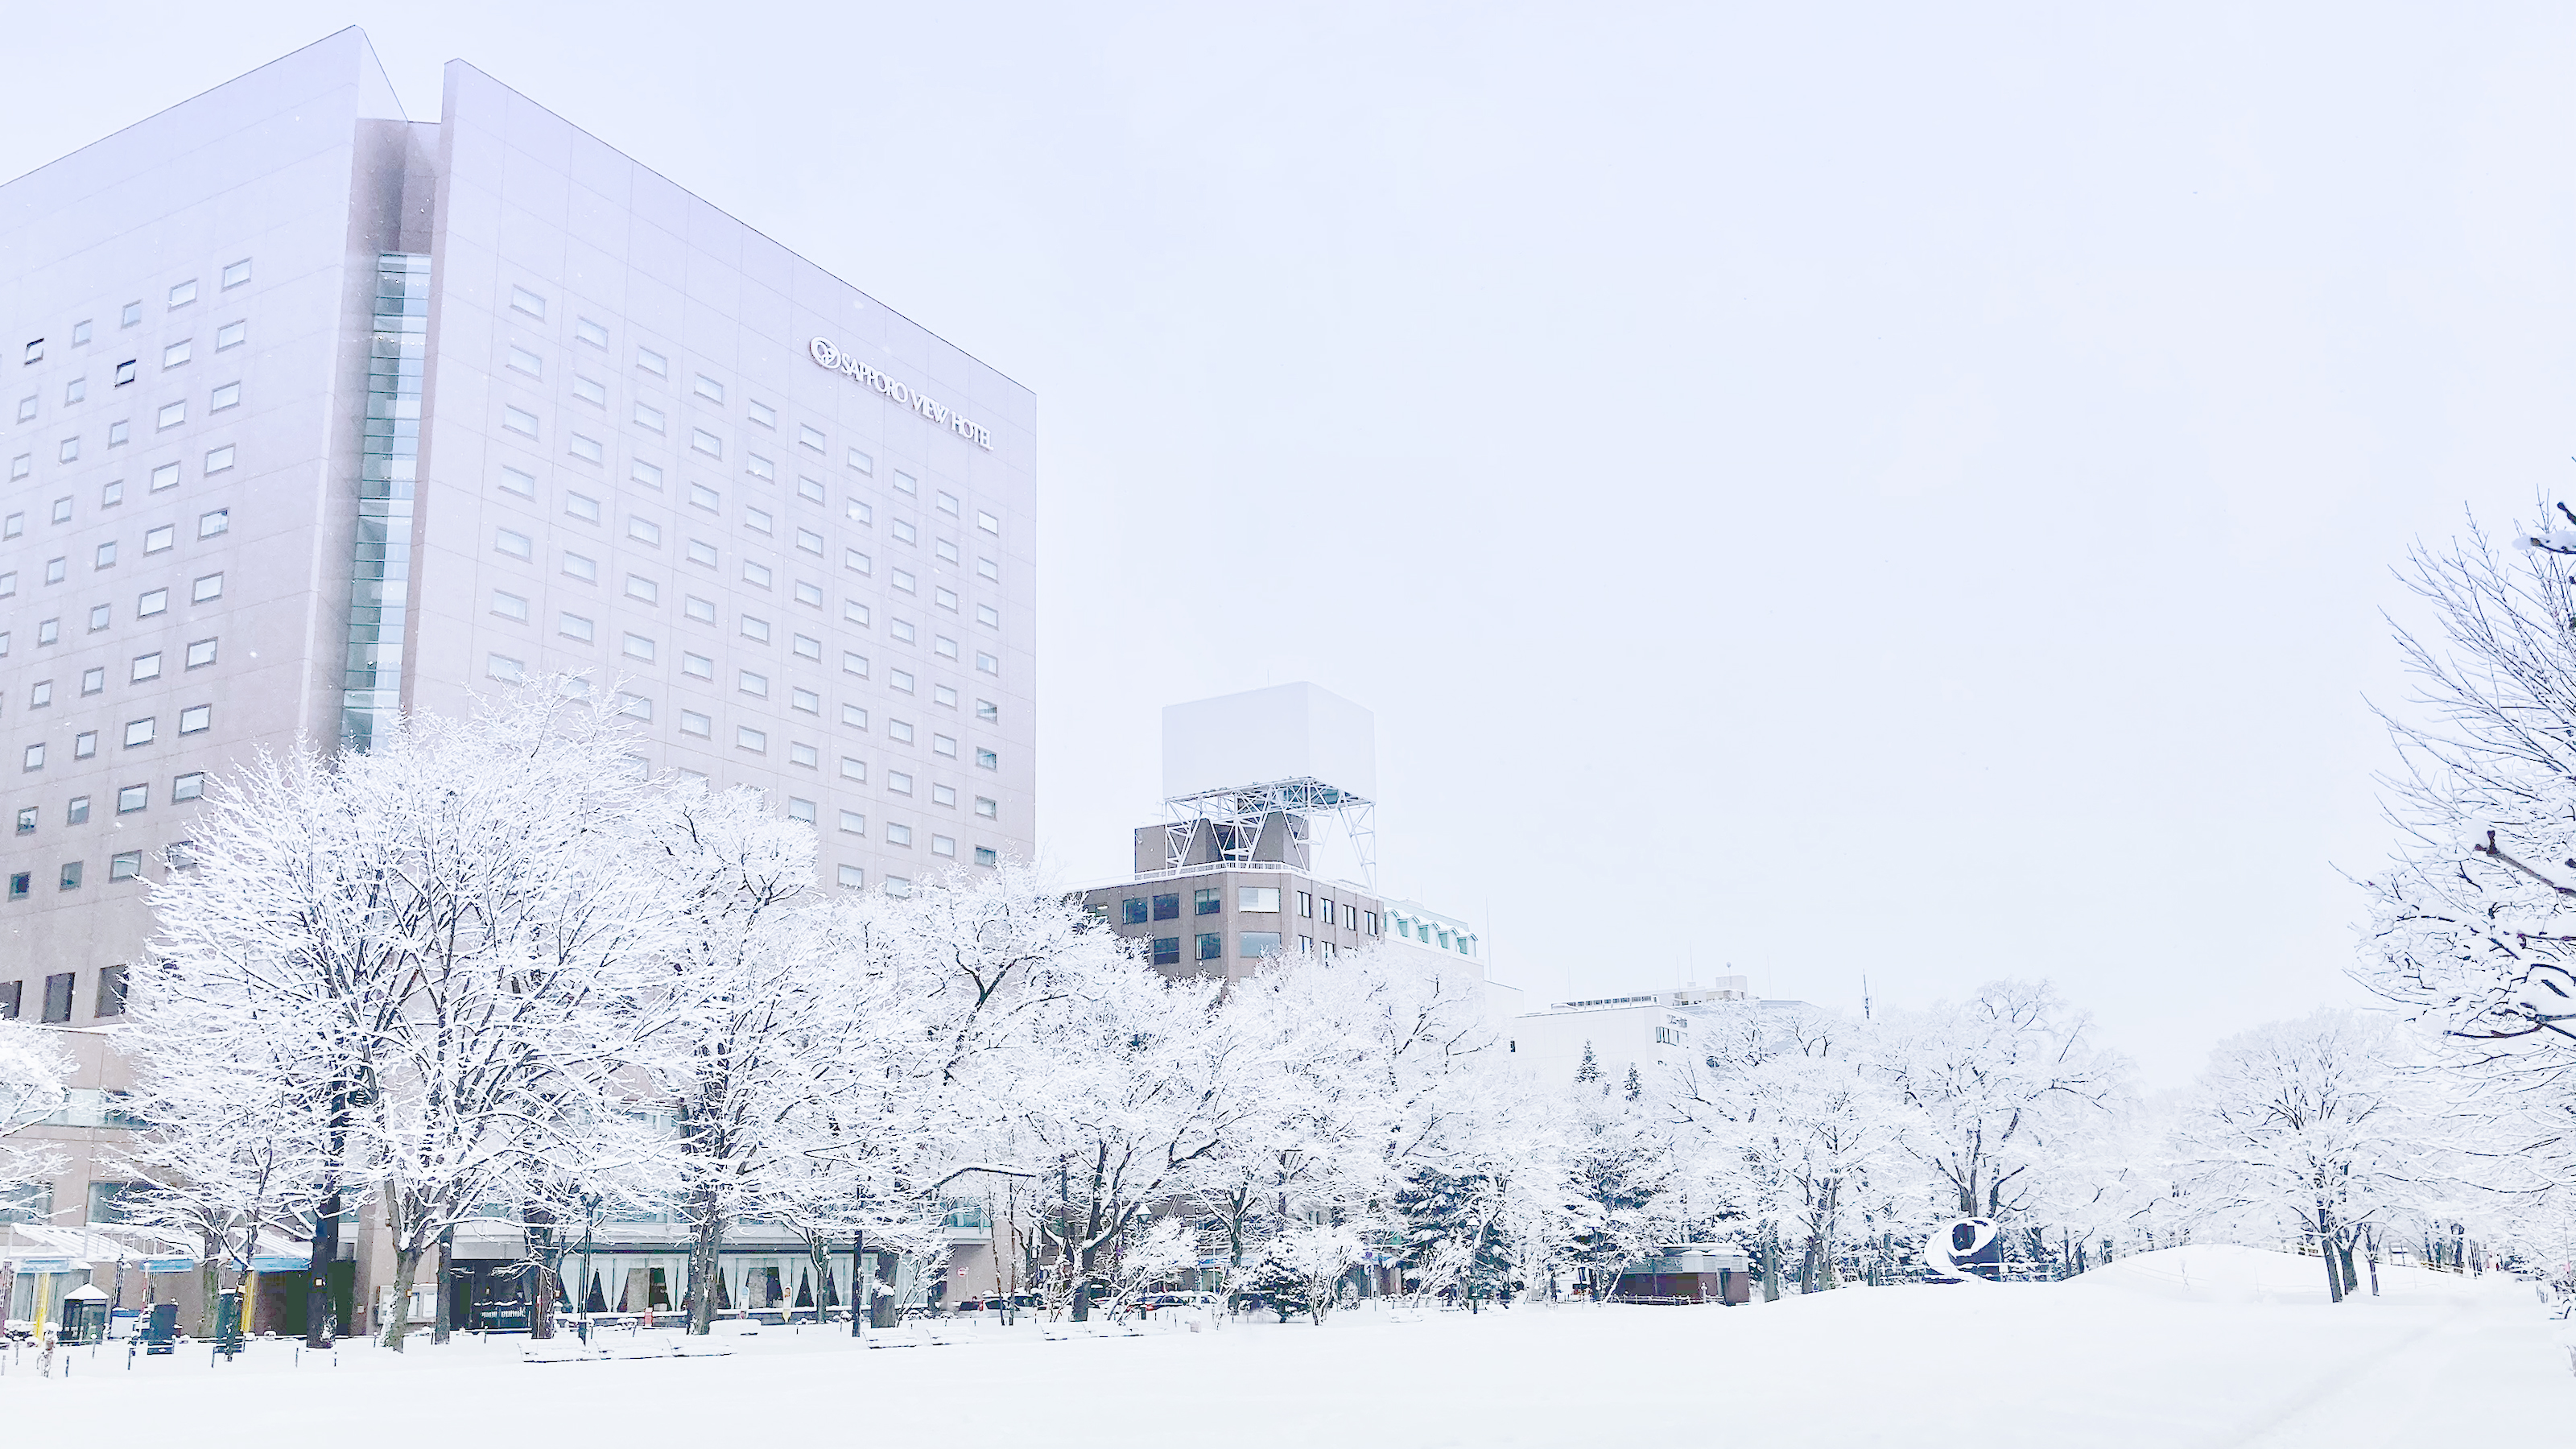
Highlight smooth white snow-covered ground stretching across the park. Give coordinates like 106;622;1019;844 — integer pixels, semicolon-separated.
0;1248;2576;1449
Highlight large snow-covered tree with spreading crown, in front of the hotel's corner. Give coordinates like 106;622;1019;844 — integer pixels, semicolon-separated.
137;681;672;1348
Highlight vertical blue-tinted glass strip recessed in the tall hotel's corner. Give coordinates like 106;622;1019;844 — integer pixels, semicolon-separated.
340;253;430;750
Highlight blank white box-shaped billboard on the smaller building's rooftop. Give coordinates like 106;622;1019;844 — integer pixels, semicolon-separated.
1162;683;1378;799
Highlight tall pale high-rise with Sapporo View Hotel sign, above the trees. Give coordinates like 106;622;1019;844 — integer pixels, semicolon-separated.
0;31;1035;1024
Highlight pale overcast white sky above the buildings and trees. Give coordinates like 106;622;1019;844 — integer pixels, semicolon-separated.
0;0;2576;1080
